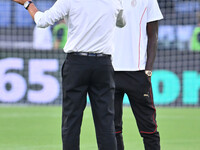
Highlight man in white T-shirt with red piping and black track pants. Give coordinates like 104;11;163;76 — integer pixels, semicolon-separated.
113;0;163;150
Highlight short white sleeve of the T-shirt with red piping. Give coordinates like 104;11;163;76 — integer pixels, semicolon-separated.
147;0;163;22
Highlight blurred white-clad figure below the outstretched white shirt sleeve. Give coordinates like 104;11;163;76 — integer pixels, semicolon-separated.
33;26;53;50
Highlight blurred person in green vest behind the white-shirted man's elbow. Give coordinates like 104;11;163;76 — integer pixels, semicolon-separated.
53;20;68;50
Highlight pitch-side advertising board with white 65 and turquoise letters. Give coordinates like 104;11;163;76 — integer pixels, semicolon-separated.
0;49;200;106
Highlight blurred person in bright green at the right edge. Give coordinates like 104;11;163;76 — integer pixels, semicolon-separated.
191;12;200;52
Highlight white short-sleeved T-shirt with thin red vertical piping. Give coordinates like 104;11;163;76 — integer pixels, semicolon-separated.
113;0;163;71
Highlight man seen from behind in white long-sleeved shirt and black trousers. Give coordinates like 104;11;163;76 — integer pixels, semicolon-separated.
13;0;125;150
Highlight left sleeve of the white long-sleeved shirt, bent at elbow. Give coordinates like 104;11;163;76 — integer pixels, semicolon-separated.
34;0;70;28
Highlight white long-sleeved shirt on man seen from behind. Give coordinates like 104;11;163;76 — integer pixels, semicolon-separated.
34;0;122;54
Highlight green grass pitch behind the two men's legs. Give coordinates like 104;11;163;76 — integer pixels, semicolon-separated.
0;106;200;150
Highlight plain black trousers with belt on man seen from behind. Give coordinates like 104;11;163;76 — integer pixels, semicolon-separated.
62;54;116;150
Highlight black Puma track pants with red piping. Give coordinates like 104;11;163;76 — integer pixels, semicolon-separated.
114;71;160;150
